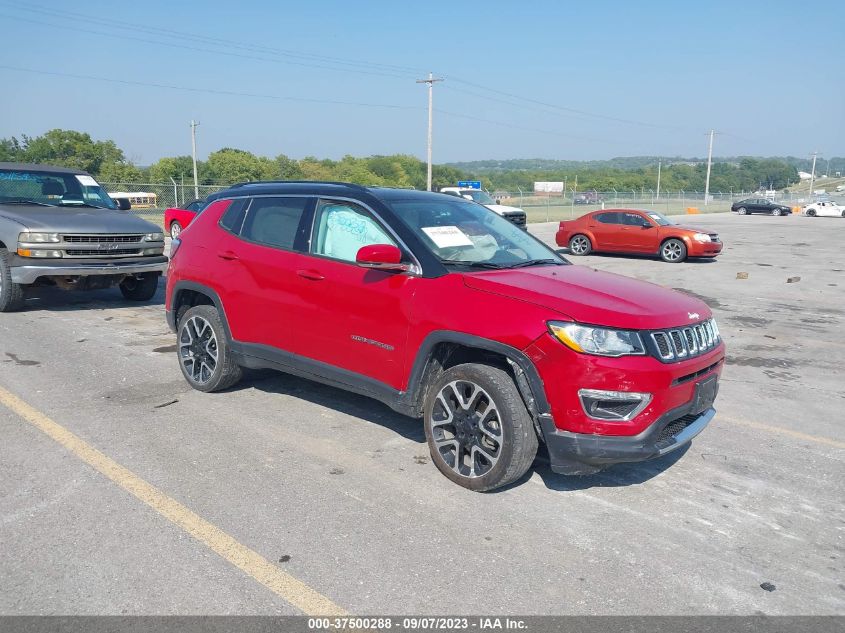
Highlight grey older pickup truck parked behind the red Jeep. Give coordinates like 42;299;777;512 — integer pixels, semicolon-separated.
0;163;167;312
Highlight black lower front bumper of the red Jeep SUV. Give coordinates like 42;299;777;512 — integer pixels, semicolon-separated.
540;399;716;475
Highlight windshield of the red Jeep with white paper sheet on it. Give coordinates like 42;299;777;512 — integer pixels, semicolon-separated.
389;197;568;268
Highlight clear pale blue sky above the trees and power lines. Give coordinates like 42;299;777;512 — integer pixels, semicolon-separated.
0;0;845;165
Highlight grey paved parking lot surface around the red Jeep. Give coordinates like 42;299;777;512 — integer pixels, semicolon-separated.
0;214;845;615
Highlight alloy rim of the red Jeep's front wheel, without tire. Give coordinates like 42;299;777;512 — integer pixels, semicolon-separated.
431;380;504;478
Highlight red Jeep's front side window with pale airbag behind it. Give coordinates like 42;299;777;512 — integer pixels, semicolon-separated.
311;200;396;262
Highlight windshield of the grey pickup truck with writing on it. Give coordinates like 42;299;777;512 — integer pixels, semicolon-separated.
0;169;117;209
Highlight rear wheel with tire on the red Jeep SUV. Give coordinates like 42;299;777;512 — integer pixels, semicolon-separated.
176;305;243;393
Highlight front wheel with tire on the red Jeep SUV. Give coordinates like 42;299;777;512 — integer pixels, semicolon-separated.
424;363;538;492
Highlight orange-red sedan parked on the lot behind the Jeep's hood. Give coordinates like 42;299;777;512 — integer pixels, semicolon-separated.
555;209;722;263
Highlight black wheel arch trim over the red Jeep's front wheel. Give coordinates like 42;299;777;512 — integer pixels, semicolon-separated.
405;330;551;428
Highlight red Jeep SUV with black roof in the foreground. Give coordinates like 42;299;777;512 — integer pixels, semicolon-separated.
166;182;725;491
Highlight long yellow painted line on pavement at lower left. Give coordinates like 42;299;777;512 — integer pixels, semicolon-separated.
0;387;346;615
